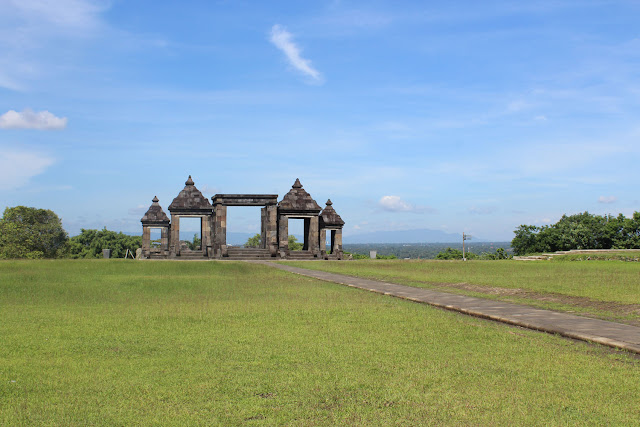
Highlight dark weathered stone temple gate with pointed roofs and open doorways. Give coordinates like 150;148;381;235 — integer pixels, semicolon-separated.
140;176;344;259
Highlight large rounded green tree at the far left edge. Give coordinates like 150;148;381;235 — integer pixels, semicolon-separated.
0;206;68;258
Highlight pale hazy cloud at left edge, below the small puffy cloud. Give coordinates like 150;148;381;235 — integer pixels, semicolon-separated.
0;149;55;190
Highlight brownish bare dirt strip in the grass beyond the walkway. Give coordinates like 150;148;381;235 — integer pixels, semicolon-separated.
435;283;640;326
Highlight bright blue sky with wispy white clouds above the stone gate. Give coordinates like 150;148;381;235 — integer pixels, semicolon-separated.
0;0;640;243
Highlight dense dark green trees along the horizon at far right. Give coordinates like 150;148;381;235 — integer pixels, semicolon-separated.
511;212;640;255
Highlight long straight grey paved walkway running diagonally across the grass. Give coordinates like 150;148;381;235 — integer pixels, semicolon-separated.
258;261;640;354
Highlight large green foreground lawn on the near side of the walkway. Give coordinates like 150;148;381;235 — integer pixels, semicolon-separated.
0;260;640;426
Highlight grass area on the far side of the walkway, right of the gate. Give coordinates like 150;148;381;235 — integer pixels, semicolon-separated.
285;260;640;325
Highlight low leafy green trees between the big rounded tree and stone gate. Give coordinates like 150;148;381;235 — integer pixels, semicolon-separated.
69;227;142;258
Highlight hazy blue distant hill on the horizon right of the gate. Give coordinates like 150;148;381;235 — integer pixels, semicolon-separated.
343;228;485;244
